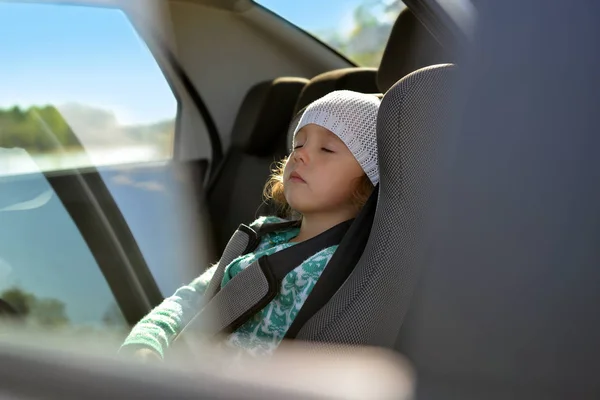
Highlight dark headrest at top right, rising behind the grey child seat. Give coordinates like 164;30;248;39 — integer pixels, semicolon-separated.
377;8;451;93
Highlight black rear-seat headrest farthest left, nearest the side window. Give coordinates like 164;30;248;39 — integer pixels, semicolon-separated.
231;78;308;157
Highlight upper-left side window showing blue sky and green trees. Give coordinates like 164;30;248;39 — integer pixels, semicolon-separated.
0;2;177;173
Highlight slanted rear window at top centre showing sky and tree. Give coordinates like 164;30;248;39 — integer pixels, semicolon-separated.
255;0;405;67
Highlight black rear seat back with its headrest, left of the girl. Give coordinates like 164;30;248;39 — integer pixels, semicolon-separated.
207;78;308;254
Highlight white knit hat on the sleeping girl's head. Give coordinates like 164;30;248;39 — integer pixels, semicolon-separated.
294;90;380;185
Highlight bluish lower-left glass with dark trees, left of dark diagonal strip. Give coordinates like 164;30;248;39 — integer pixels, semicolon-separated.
0;153;127;332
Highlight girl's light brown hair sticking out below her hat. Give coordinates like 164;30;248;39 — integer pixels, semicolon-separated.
263;157;374;219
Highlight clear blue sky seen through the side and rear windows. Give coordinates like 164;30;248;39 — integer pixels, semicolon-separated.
0;0;360;124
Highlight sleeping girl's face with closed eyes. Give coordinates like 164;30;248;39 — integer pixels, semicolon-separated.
283;124;364;215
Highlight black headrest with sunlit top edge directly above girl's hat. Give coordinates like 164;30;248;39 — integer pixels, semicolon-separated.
294;68;379;113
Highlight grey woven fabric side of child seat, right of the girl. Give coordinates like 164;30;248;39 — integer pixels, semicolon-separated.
297;65;455;347
